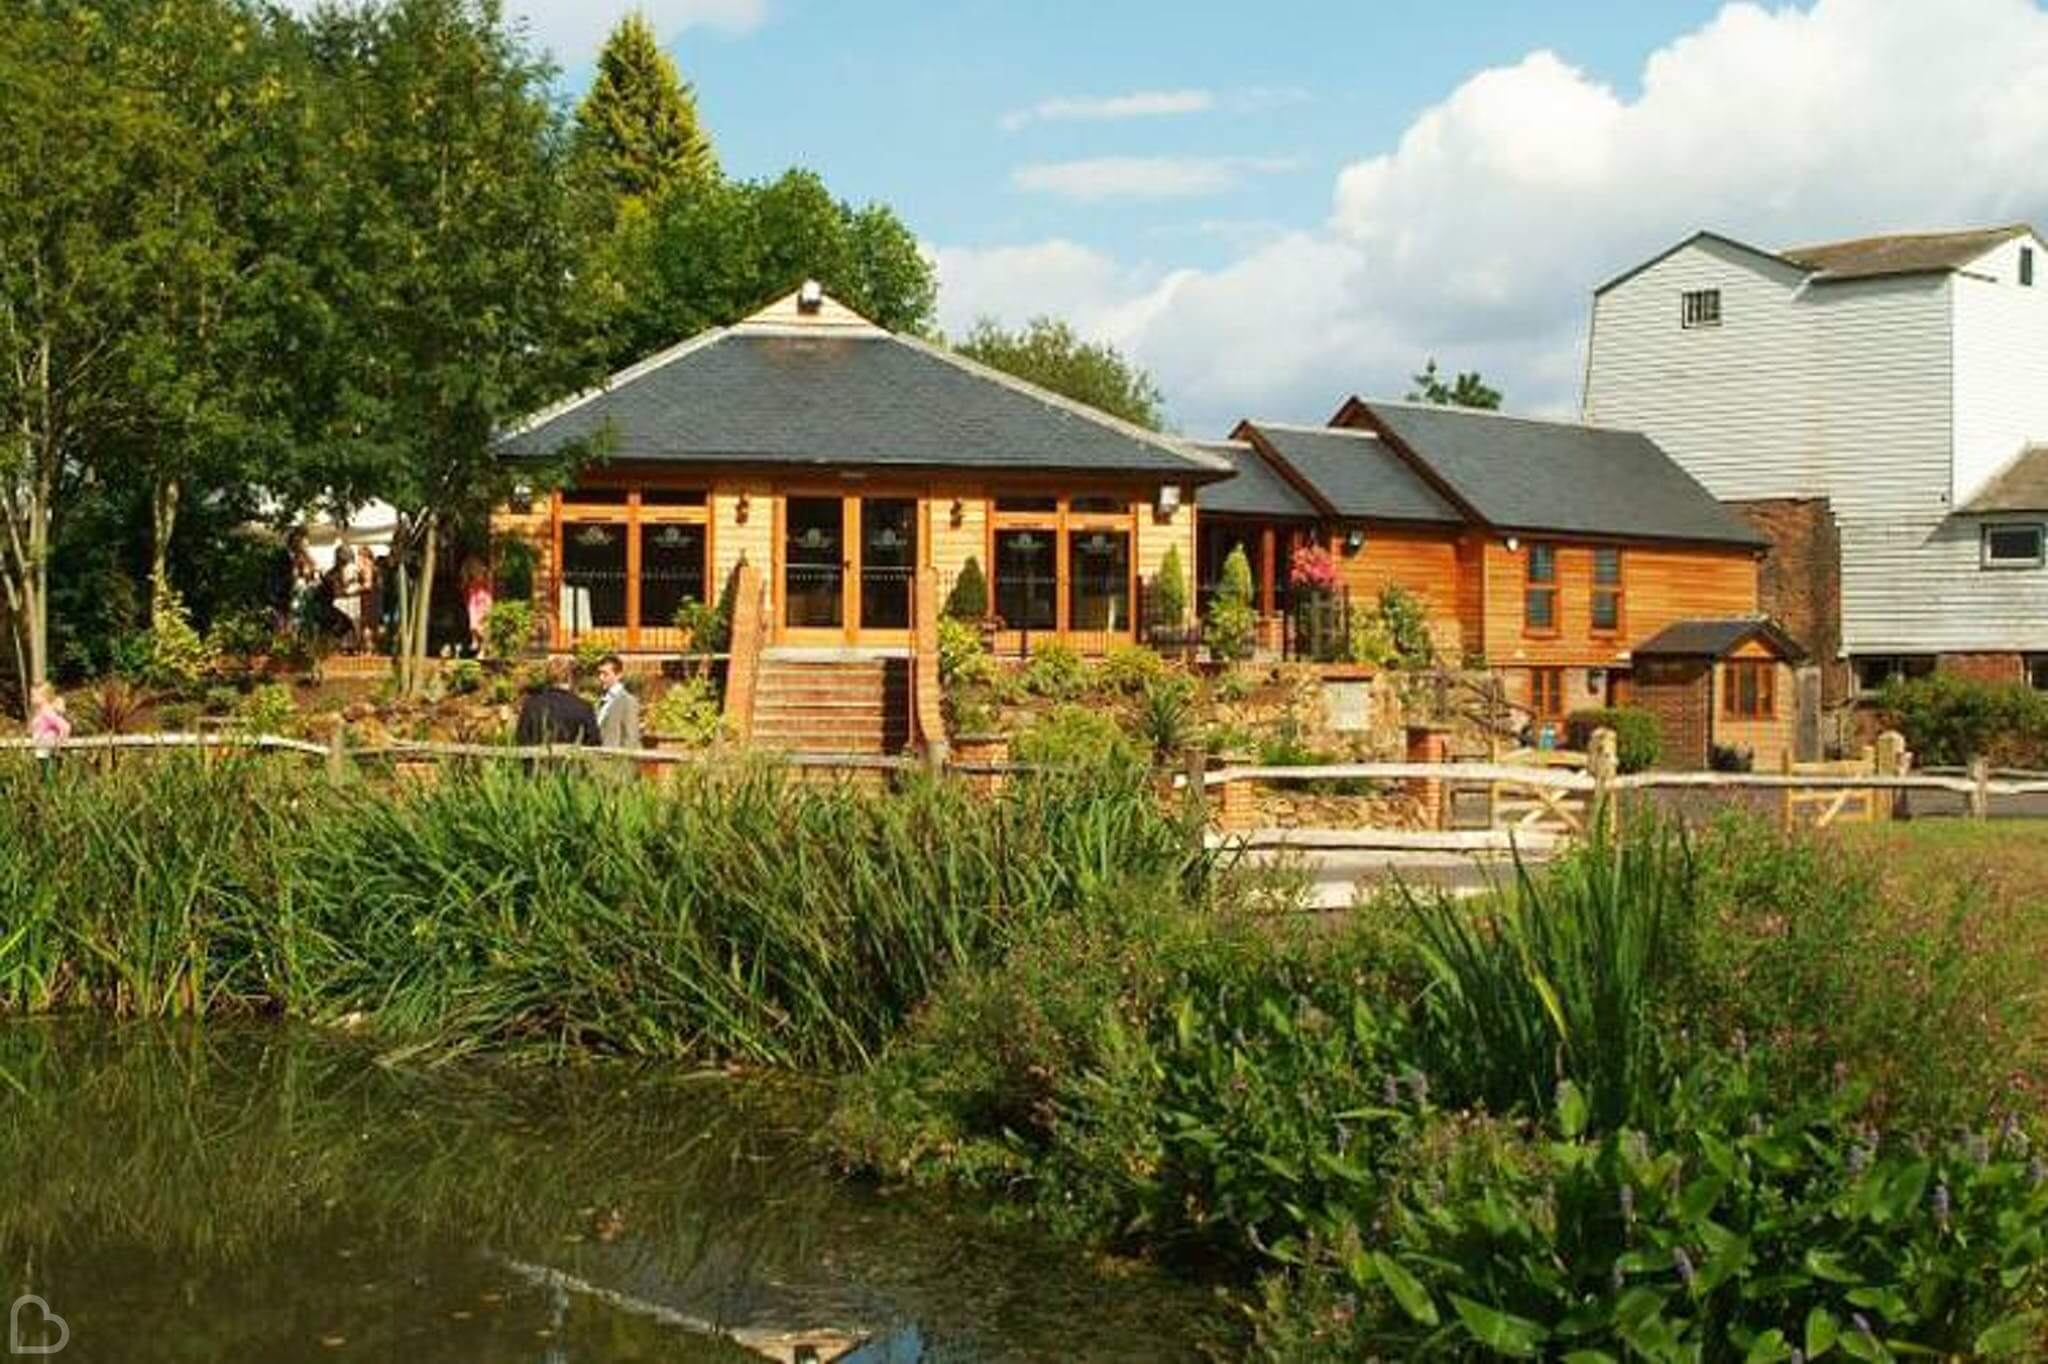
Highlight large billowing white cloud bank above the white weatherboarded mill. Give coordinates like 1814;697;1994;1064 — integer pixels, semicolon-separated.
938;0;2048;432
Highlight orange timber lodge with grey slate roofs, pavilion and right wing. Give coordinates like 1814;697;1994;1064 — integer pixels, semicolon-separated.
494;285;1796;762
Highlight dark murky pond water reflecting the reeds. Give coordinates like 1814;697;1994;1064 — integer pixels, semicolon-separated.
0;1022;1235;1364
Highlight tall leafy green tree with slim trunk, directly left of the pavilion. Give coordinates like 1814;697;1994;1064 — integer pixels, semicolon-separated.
299;0;592;692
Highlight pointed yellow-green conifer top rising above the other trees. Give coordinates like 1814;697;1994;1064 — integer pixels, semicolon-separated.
575;10;719;201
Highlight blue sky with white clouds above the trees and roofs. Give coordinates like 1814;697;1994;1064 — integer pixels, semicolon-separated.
520;0;2048;434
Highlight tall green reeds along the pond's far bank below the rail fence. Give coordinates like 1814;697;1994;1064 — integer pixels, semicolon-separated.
0;756;1206;1067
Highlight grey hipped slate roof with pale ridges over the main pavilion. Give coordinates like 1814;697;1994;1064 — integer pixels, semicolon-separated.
498;284;1231;483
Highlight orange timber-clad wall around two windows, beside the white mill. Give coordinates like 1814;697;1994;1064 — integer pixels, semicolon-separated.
1481;537;1757;668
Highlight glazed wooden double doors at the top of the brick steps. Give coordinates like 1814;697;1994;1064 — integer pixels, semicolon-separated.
780;492;918;645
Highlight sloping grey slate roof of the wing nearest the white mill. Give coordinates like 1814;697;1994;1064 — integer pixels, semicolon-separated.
1337;397;1769;549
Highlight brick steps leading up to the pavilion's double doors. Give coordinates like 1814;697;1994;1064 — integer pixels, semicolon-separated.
754;649;909;754
